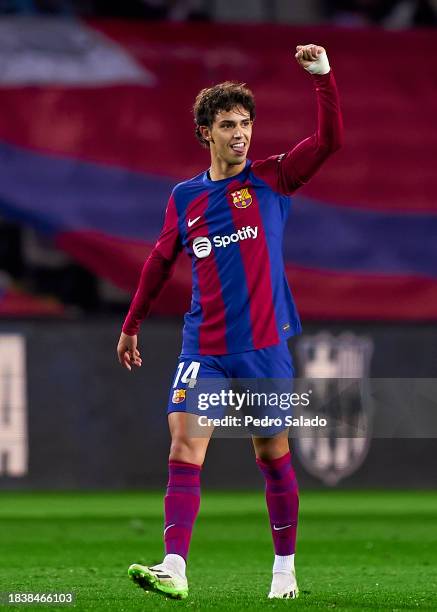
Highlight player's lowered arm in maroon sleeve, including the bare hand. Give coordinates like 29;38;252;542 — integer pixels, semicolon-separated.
117;195;182;370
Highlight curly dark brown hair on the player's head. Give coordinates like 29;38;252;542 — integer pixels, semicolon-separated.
193;81;255;147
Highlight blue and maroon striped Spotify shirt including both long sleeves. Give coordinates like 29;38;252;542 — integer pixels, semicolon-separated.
123;71;342;355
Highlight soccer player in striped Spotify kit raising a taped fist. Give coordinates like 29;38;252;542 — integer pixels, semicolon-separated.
117;44;343;598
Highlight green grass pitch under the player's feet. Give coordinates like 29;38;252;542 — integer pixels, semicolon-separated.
0;491;437;612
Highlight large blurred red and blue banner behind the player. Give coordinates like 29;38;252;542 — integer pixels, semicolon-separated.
0;18;437;320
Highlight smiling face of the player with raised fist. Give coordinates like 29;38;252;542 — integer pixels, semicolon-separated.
209;107;253;165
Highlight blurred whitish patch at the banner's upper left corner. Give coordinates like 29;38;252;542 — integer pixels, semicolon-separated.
0;17;156;87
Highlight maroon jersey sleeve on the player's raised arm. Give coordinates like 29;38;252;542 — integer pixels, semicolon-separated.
252;70;343;195
